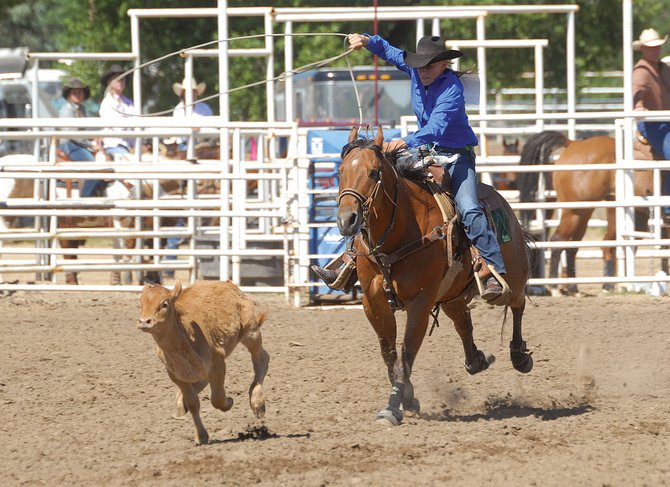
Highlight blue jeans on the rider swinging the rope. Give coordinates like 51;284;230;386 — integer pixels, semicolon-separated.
444;153;507;274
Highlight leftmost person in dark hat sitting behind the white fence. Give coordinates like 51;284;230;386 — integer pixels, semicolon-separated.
58;78;104;197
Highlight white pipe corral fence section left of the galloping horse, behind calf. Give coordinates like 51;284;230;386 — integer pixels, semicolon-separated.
0;117;298;298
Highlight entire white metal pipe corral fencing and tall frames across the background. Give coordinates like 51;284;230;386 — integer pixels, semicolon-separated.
0;0;669;304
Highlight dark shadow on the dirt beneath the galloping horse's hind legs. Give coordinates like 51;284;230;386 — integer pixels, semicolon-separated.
421;399;596;423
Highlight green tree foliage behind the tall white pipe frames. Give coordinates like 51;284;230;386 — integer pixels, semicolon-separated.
0;0;670;120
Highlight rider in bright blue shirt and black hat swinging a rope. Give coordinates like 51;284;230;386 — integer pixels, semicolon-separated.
312;34;505;301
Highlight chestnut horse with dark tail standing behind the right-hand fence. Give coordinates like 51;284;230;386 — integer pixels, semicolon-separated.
517;130;652;294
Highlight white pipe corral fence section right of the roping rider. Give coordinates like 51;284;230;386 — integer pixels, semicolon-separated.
401;111;670;289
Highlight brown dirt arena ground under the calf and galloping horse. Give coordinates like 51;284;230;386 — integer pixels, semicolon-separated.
0;292;670;486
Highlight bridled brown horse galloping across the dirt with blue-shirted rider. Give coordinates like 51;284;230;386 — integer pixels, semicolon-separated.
337;127;533;425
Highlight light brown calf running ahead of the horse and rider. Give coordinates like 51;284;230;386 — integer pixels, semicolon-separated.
138;281;270;445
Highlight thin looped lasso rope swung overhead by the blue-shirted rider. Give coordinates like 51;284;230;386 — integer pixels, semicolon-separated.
103;32;363;125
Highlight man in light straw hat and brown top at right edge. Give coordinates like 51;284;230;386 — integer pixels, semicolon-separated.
633;29;670;219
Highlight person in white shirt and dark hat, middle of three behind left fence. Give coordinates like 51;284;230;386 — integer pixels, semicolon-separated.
100;64;135;158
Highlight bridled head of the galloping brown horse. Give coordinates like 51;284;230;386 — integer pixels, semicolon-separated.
337;127;384;237
